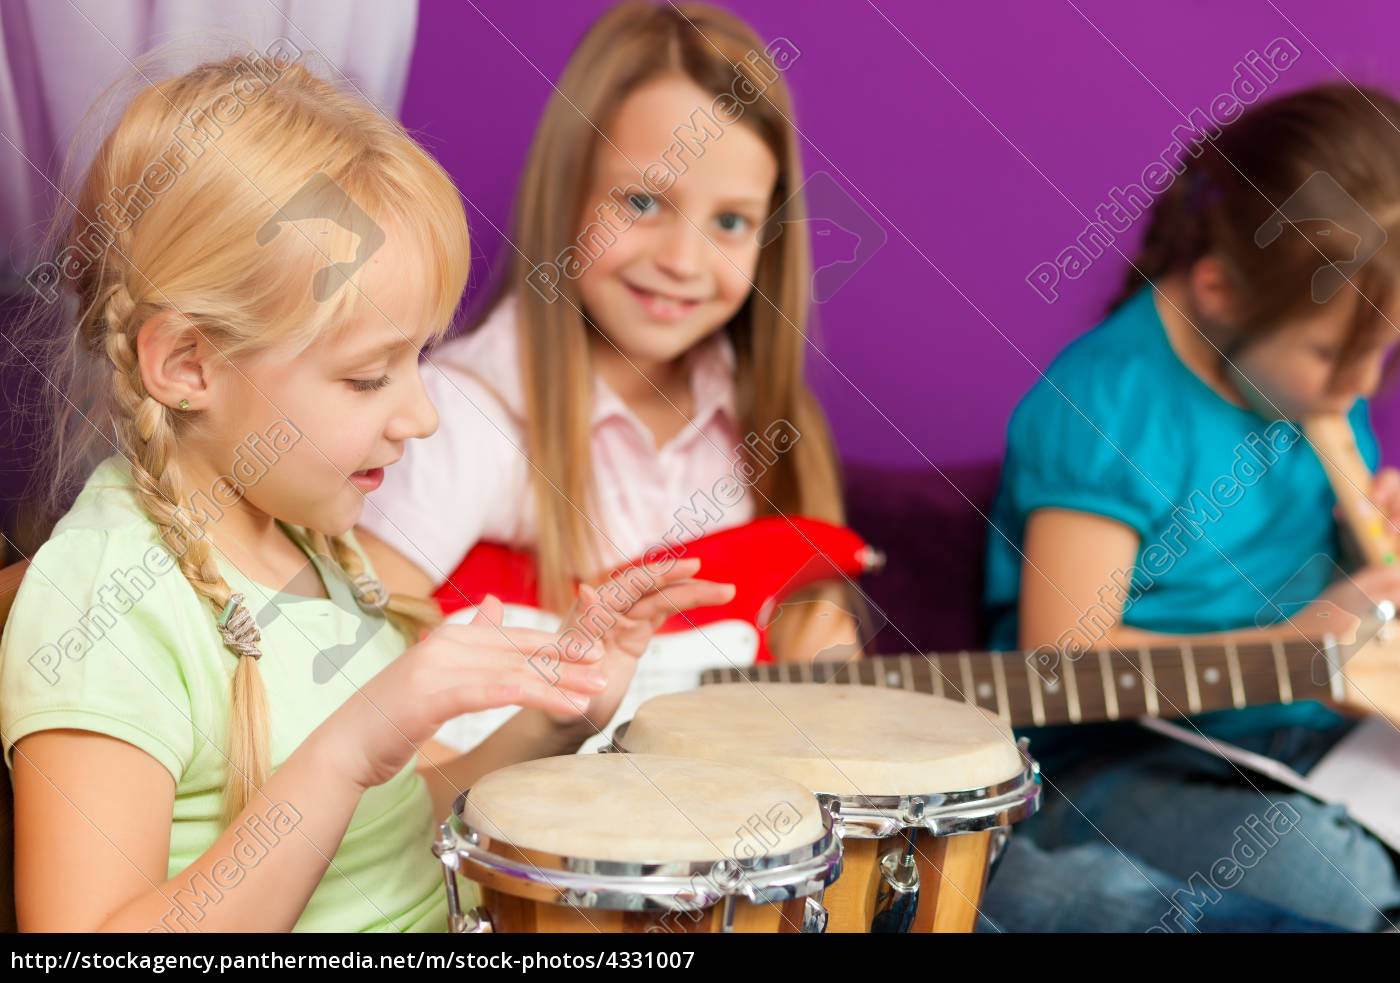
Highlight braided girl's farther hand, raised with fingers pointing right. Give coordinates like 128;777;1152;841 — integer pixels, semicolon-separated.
547;559;735;734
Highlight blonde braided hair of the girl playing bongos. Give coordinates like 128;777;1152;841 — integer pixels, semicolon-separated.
19;50;470;822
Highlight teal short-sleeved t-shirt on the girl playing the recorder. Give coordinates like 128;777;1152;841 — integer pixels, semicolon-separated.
984;287;1379;739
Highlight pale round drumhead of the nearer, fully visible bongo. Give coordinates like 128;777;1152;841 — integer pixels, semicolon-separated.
461;755;825;863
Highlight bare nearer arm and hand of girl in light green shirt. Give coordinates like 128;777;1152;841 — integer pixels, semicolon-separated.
14;607;606;931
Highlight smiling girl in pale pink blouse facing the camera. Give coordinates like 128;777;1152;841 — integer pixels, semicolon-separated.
360;1;854;677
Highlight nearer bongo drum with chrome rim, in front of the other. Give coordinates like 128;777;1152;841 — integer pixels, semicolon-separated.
433;755;841;933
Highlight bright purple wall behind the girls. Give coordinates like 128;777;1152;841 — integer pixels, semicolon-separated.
403;0;1400;466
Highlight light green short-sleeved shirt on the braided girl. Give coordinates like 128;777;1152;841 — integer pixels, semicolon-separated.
0;456;447;931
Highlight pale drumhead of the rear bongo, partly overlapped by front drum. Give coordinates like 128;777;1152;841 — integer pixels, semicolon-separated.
620;682;1025;795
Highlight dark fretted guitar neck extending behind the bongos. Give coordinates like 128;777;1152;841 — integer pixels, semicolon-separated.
700;637;1343;727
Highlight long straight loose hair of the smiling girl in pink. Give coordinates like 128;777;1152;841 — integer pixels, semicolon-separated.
477;1;843;611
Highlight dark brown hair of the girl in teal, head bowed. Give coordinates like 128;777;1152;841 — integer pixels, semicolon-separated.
1112;83;1400;378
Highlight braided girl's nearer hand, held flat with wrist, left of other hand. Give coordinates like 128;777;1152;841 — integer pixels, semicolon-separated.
308;597;608;788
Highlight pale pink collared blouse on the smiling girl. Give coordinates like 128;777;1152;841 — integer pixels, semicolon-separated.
360;298;755;584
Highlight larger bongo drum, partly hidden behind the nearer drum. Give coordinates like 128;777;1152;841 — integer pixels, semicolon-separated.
615;683;1040;933
